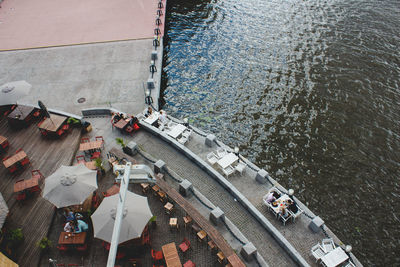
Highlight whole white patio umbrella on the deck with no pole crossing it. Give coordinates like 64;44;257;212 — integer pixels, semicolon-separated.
43;164;97;208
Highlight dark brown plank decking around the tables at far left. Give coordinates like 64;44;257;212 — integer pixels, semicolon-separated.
0;118;81;267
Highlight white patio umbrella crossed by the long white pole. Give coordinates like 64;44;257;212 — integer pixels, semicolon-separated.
92;191;153;244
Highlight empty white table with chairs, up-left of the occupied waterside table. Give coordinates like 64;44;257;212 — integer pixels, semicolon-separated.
207;147;247;178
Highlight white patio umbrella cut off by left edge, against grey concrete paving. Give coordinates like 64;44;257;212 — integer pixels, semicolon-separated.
0;81;32;106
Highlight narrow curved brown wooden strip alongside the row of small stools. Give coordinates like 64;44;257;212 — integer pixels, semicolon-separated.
157;174;245;266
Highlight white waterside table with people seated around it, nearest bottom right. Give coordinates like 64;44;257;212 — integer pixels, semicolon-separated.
263;187;304;225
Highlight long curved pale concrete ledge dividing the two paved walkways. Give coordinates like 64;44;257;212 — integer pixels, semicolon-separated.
141;123;310;266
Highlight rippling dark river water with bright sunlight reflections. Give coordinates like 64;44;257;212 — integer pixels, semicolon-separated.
163;0;400;266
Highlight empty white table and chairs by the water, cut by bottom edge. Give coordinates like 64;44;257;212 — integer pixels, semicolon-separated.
311;241;355;267
